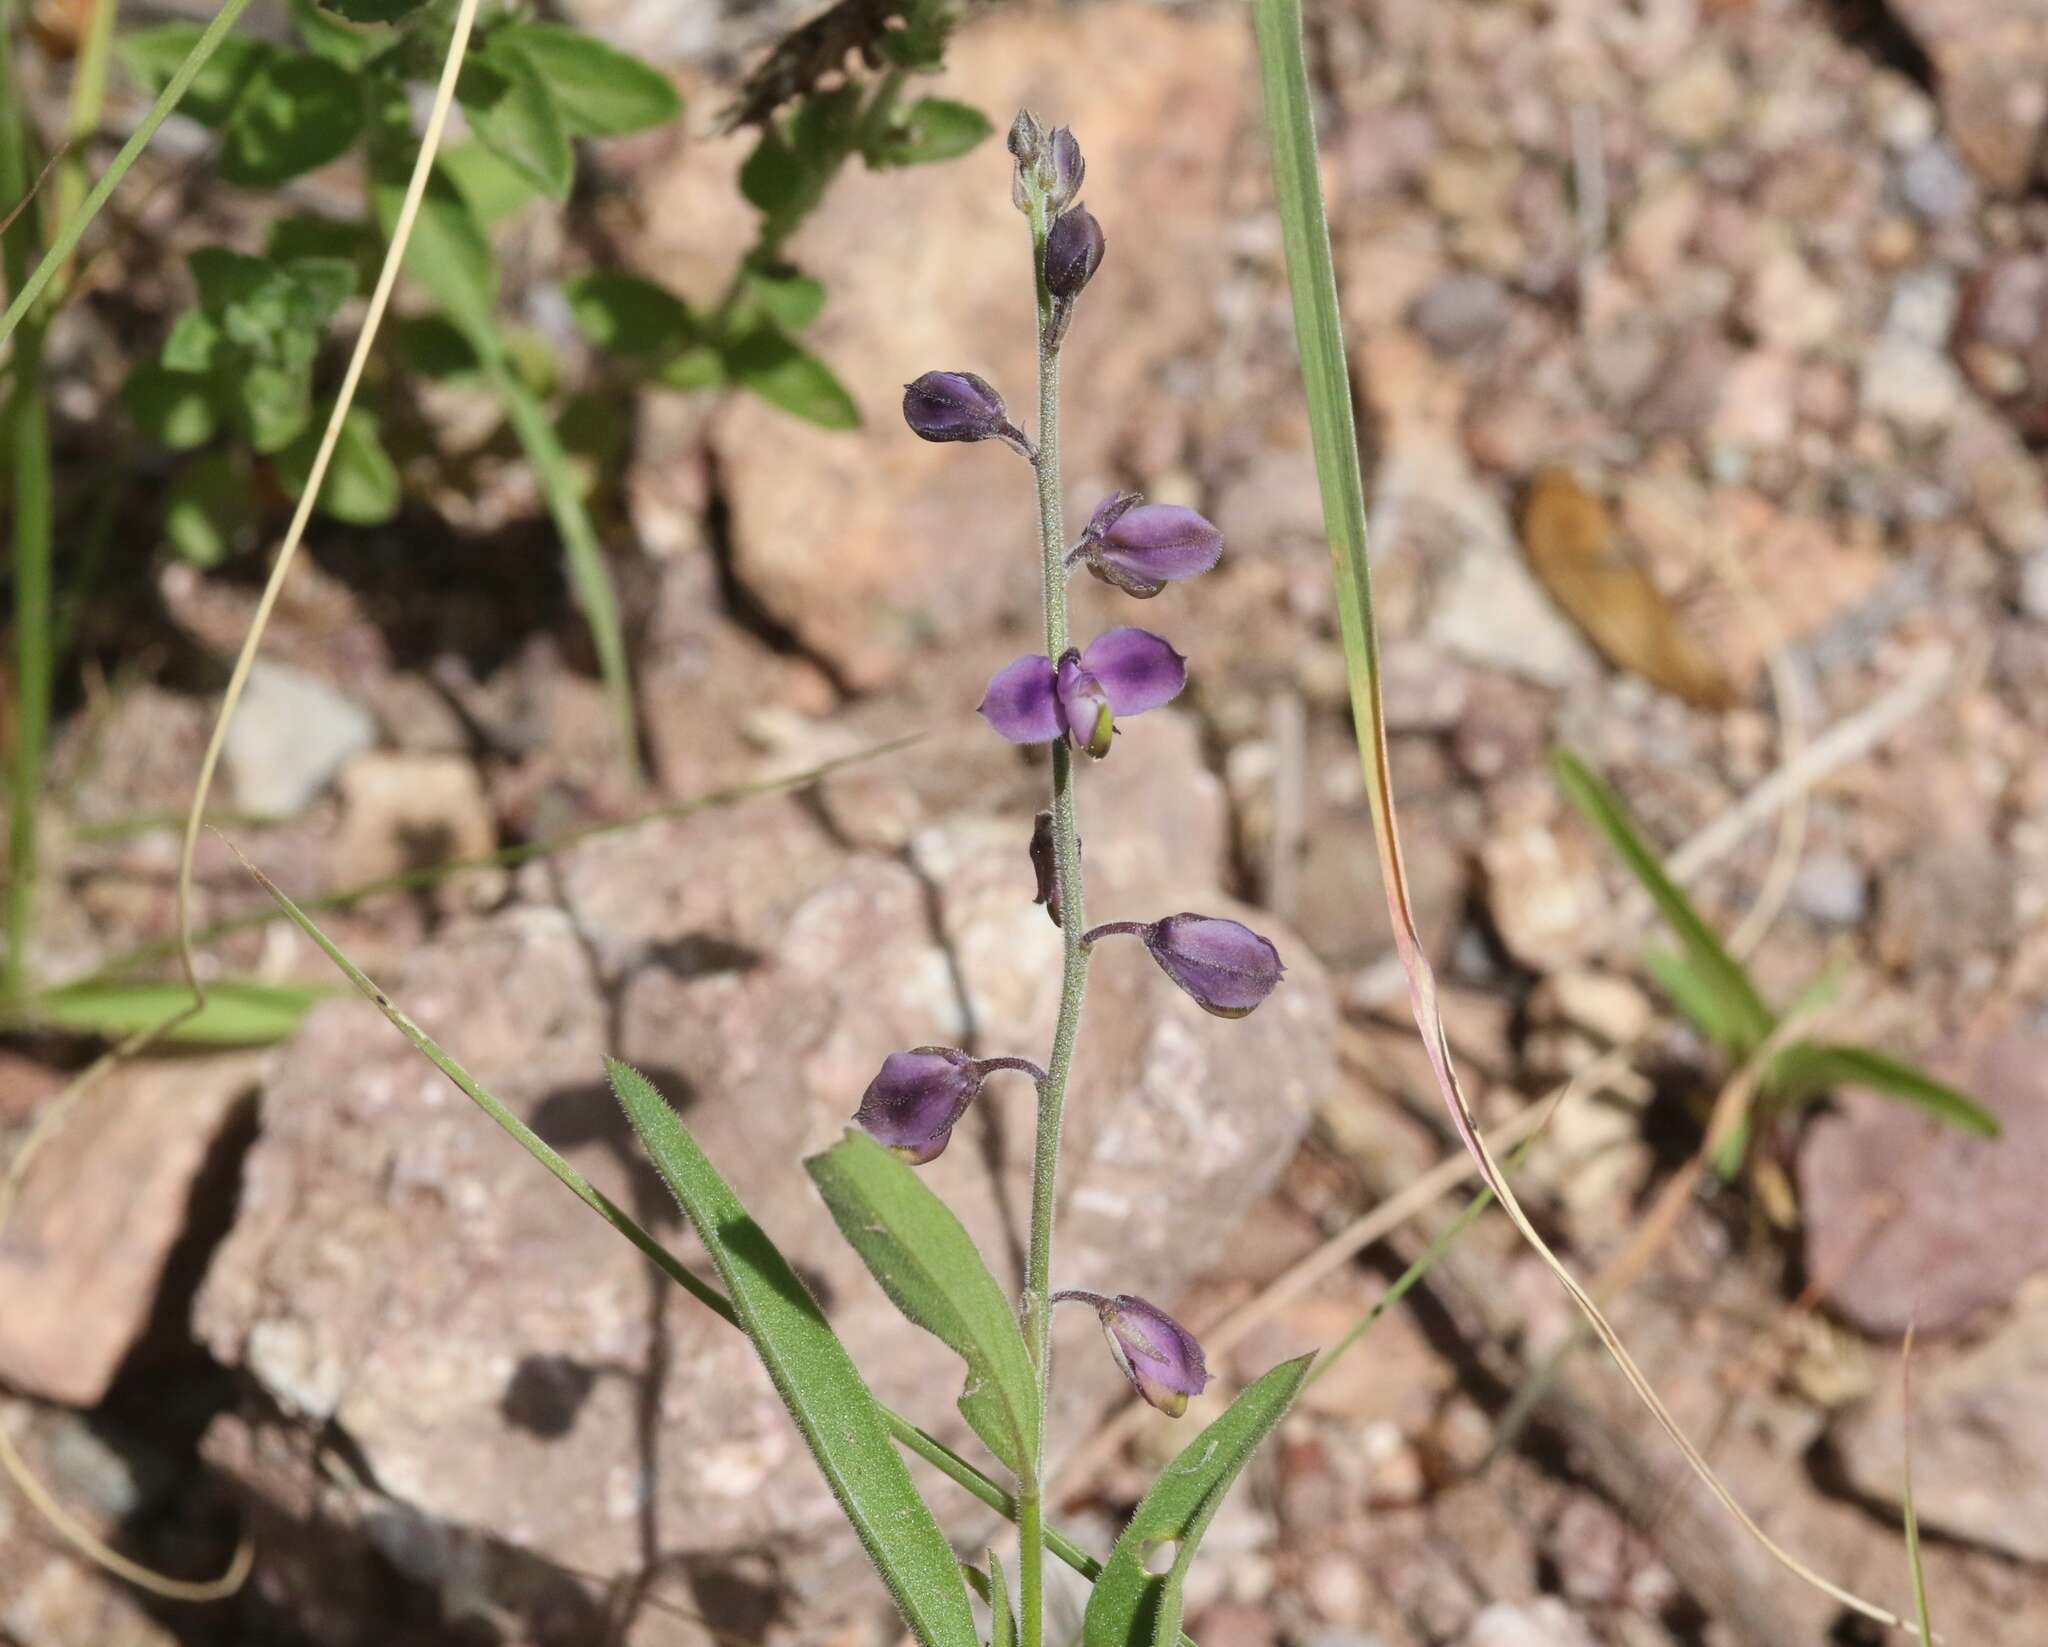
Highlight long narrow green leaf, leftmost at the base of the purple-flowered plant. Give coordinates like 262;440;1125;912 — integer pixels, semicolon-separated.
608;1059;979;1647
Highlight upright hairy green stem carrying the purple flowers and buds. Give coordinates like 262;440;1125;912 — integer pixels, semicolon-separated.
1018;183;1087;1647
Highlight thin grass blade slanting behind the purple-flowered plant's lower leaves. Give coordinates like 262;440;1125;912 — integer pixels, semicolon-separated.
236;856;1155;1614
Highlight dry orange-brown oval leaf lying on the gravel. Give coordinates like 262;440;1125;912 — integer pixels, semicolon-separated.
1522;469;1735;709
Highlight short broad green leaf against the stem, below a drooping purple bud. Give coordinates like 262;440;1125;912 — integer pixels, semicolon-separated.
805;1133;1038;1479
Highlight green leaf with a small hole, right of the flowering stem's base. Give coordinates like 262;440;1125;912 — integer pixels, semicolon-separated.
1081;1356;1315;1647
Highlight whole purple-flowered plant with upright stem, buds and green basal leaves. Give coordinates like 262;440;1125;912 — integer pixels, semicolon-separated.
581;113;1311;1647
